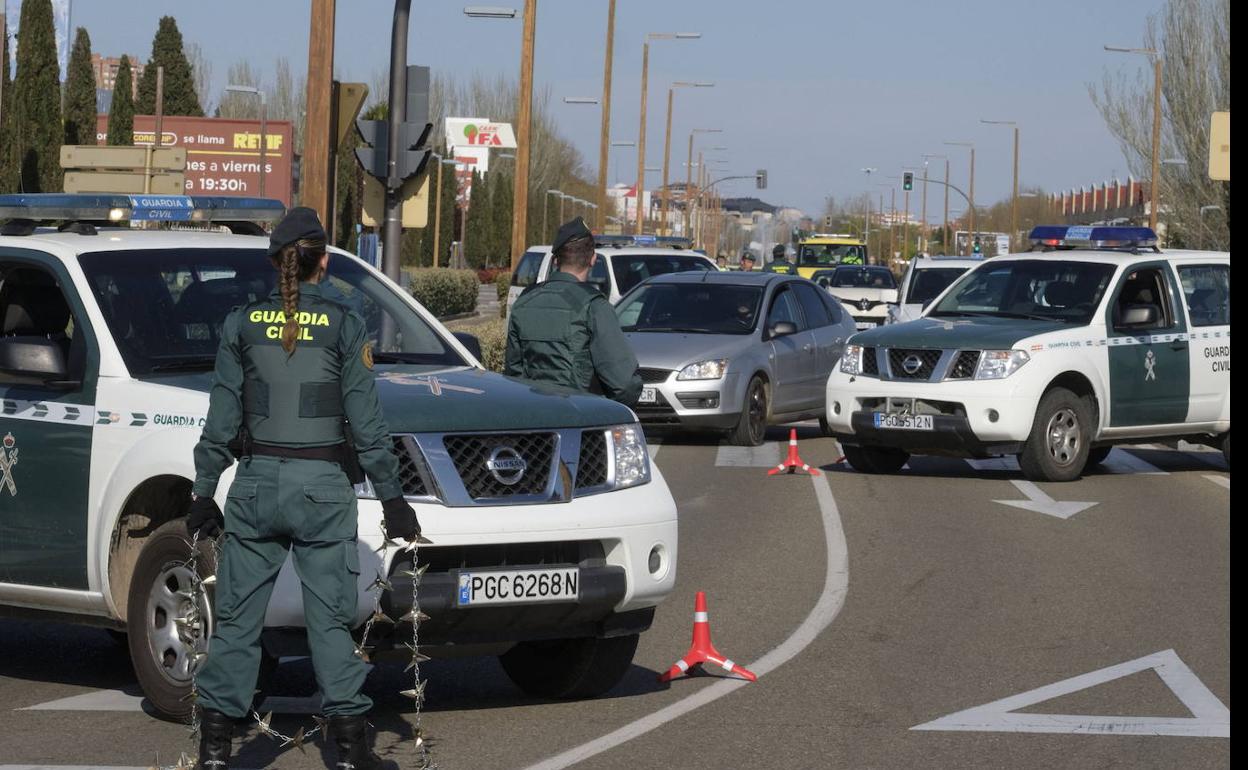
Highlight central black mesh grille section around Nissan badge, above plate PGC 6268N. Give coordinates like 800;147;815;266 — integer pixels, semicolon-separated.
443;433;557;500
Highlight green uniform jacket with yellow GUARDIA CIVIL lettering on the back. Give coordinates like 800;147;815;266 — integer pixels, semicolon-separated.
192;283;403;500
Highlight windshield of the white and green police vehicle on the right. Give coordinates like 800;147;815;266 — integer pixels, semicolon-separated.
929;260;1114;326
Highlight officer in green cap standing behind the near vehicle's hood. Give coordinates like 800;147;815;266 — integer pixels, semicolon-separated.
505;217;641;407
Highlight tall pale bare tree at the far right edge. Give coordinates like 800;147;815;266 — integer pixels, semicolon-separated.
1088;0;1231;250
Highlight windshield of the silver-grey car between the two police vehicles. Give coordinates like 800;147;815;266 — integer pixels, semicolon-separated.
615;283;763;334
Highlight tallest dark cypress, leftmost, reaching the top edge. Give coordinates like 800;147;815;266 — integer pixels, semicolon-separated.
9;0;65;192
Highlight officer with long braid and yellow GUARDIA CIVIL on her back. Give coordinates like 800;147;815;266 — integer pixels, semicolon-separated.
187;208;421;770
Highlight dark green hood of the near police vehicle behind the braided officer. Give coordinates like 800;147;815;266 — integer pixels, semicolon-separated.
137;366;635;433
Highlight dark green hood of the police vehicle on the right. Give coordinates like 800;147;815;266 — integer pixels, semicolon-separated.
852;318;1070;351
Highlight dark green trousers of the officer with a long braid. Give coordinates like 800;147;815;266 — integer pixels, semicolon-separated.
196;457;372;718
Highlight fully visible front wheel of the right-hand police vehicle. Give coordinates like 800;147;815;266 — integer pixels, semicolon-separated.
1018;388;1092;482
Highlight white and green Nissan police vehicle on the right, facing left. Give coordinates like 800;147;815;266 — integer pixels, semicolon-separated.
826;227;1231;480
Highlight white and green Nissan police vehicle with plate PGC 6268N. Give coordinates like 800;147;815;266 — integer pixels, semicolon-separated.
0;195;676;716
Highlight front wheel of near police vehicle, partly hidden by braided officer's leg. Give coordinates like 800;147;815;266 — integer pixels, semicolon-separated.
126;519;216;720
